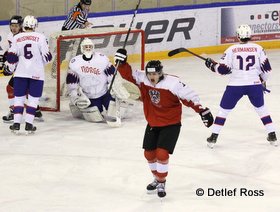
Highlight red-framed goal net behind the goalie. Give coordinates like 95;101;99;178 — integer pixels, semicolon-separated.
42;27;145;111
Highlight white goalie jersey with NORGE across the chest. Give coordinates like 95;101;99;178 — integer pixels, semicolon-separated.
66;52;115;99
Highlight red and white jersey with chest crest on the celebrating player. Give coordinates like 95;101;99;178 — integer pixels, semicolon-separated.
129;71;203;127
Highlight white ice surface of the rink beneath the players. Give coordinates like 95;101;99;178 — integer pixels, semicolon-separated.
0;50;280;212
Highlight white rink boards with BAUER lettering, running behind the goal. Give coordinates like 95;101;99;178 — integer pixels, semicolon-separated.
0;3;280;54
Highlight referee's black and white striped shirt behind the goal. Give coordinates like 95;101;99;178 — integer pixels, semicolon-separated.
62;3;88;30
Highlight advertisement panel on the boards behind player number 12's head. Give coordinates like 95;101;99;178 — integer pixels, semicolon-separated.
221;4;280;44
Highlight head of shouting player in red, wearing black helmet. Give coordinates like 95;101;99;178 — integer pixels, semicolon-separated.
145;60;163;84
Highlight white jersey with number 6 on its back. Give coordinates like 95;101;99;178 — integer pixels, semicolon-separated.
7;32;52;80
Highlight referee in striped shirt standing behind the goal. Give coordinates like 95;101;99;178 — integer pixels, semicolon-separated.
62;0;92;31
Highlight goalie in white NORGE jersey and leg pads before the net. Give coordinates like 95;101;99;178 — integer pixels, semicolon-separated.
66;38;129;126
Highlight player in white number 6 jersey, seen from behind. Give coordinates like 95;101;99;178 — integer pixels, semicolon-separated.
6;15;52;133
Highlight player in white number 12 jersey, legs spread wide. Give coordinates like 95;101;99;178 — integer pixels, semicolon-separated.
205;24;277;148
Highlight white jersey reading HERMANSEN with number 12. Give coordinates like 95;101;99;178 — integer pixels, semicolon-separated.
215;43;271;86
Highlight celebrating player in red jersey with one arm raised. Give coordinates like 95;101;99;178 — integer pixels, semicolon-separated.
115;50;213;198
